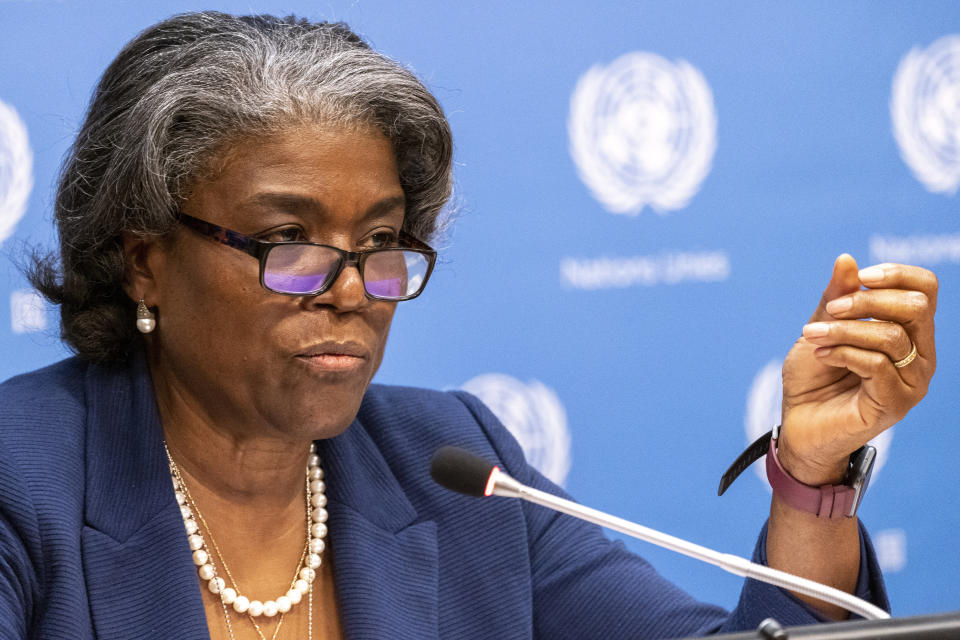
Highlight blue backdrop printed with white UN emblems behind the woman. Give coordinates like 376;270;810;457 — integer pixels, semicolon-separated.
0;0;960;615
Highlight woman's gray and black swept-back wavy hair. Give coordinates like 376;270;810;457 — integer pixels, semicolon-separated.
29;12;453;362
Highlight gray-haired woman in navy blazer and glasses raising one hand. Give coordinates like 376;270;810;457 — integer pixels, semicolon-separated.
0;13;936;639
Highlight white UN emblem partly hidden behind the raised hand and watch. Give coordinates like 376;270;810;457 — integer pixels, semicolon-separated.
744;360;893;489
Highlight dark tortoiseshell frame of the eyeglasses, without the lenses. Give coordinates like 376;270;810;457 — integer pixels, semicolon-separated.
177;211;437;302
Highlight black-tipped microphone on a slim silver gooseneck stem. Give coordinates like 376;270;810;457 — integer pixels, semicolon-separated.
430;446;890;620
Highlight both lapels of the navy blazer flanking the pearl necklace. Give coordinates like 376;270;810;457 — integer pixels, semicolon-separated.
81;354;438;640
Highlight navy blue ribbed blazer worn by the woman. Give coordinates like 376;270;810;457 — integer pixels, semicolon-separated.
0;359;886;640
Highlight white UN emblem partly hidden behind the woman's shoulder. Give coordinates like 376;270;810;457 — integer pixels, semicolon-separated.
462;373;570;486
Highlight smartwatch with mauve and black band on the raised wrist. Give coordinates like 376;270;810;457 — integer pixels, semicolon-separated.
717;425;877;518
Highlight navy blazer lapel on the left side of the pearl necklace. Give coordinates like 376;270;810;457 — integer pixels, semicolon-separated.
81;357;209;640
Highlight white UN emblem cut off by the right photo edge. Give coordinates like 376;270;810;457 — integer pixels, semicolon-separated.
890;35;960;195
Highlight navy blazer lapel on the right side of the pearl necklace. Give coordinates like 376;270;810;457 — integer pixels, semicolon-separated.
318;421;439;640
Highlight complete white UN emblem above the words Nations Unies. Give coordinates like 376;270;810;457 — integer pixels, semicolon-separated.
567;52;717;215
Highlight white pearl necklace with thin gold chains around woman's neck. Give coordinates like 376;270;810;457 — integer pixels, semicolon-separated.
164;443;327;640
